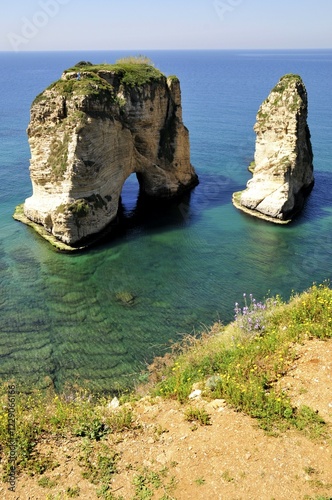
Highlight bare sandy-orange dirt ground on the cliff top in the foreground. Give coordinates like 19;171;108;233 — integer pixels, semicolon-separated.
0;340;332;500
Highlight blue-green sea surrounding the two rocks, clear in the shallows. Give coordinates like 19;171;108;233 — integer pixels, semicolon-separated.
0;50;332;392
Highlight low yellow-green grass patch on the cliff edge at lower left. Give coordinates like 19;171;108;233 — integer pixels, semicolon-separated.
0;384;135;481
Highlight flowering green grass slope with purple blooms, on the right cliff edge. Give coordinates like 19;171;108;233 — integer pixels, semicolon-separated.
153;284;332;435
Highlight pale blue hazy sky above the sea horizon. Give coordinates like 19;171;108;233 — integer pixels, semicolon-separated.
0;0;332;51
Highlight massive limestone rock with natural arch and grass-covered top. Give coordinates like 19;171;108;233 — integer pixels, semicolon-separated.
24;61;197;246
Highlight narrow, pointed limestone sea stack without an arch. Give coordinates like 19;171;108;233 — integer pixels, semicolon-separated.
233;74;314;224
